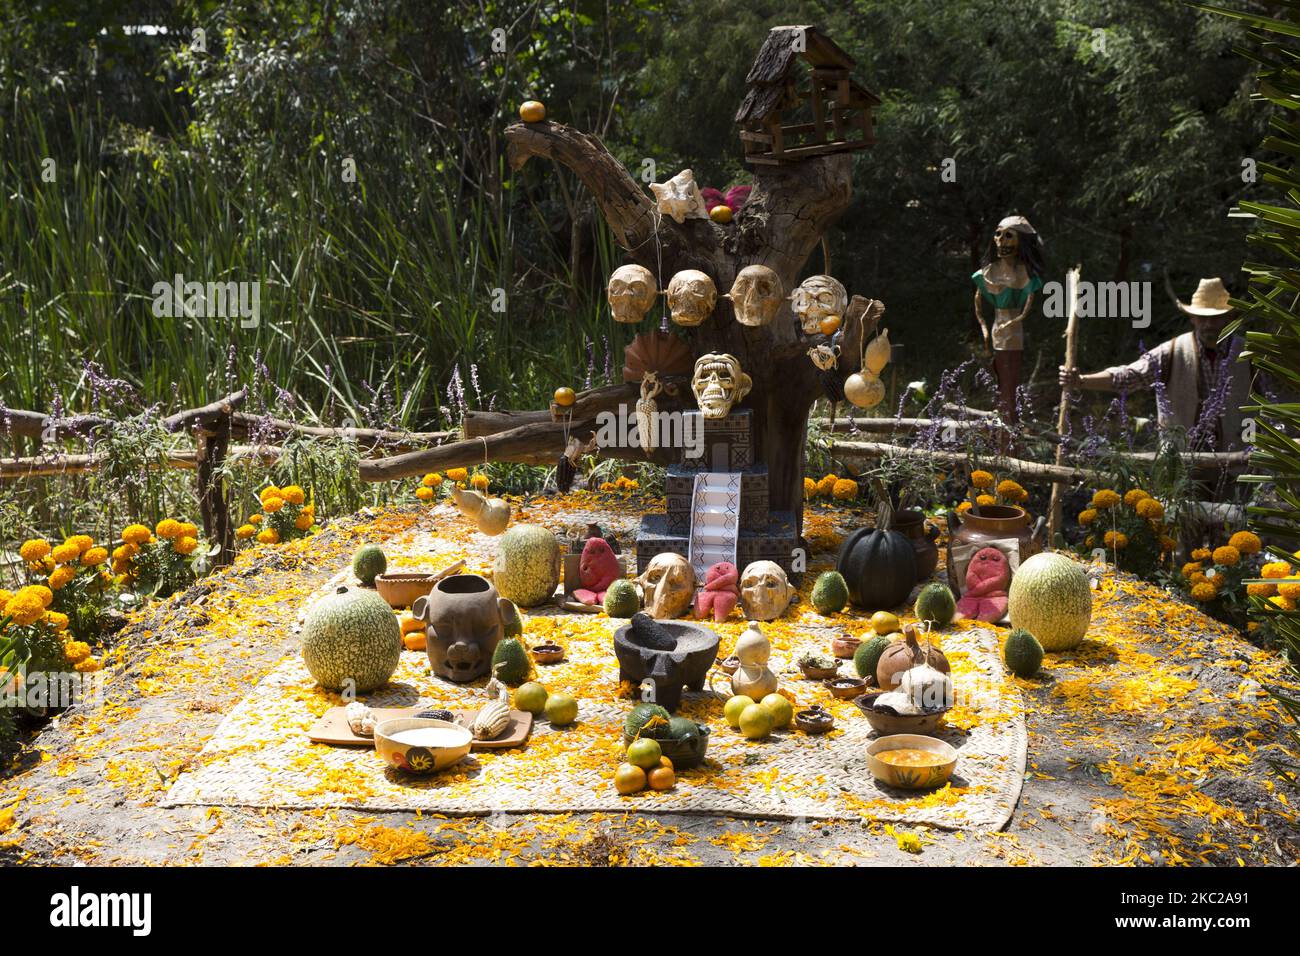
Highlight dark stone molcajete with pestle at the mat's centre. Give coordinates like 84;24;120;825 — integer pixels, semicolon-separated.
614;611;718;710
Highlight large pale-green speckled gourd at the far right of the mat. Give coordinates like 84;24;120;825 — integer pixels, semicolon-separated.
1006;551;1092;650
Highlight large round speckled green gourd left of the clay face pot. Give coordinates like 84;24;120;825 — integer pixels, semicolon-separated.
303;587;402;693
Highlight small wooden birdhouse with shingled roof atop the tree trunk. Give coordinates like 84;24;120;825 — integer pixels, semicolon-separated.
736;26;880;165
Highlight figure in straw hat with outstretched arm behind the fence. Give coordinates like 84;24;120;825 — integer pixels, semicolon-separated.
1060;278;1251;451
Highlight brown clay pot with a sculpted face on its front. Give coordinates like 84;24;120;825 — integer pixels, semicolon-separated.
411;575;515;684
